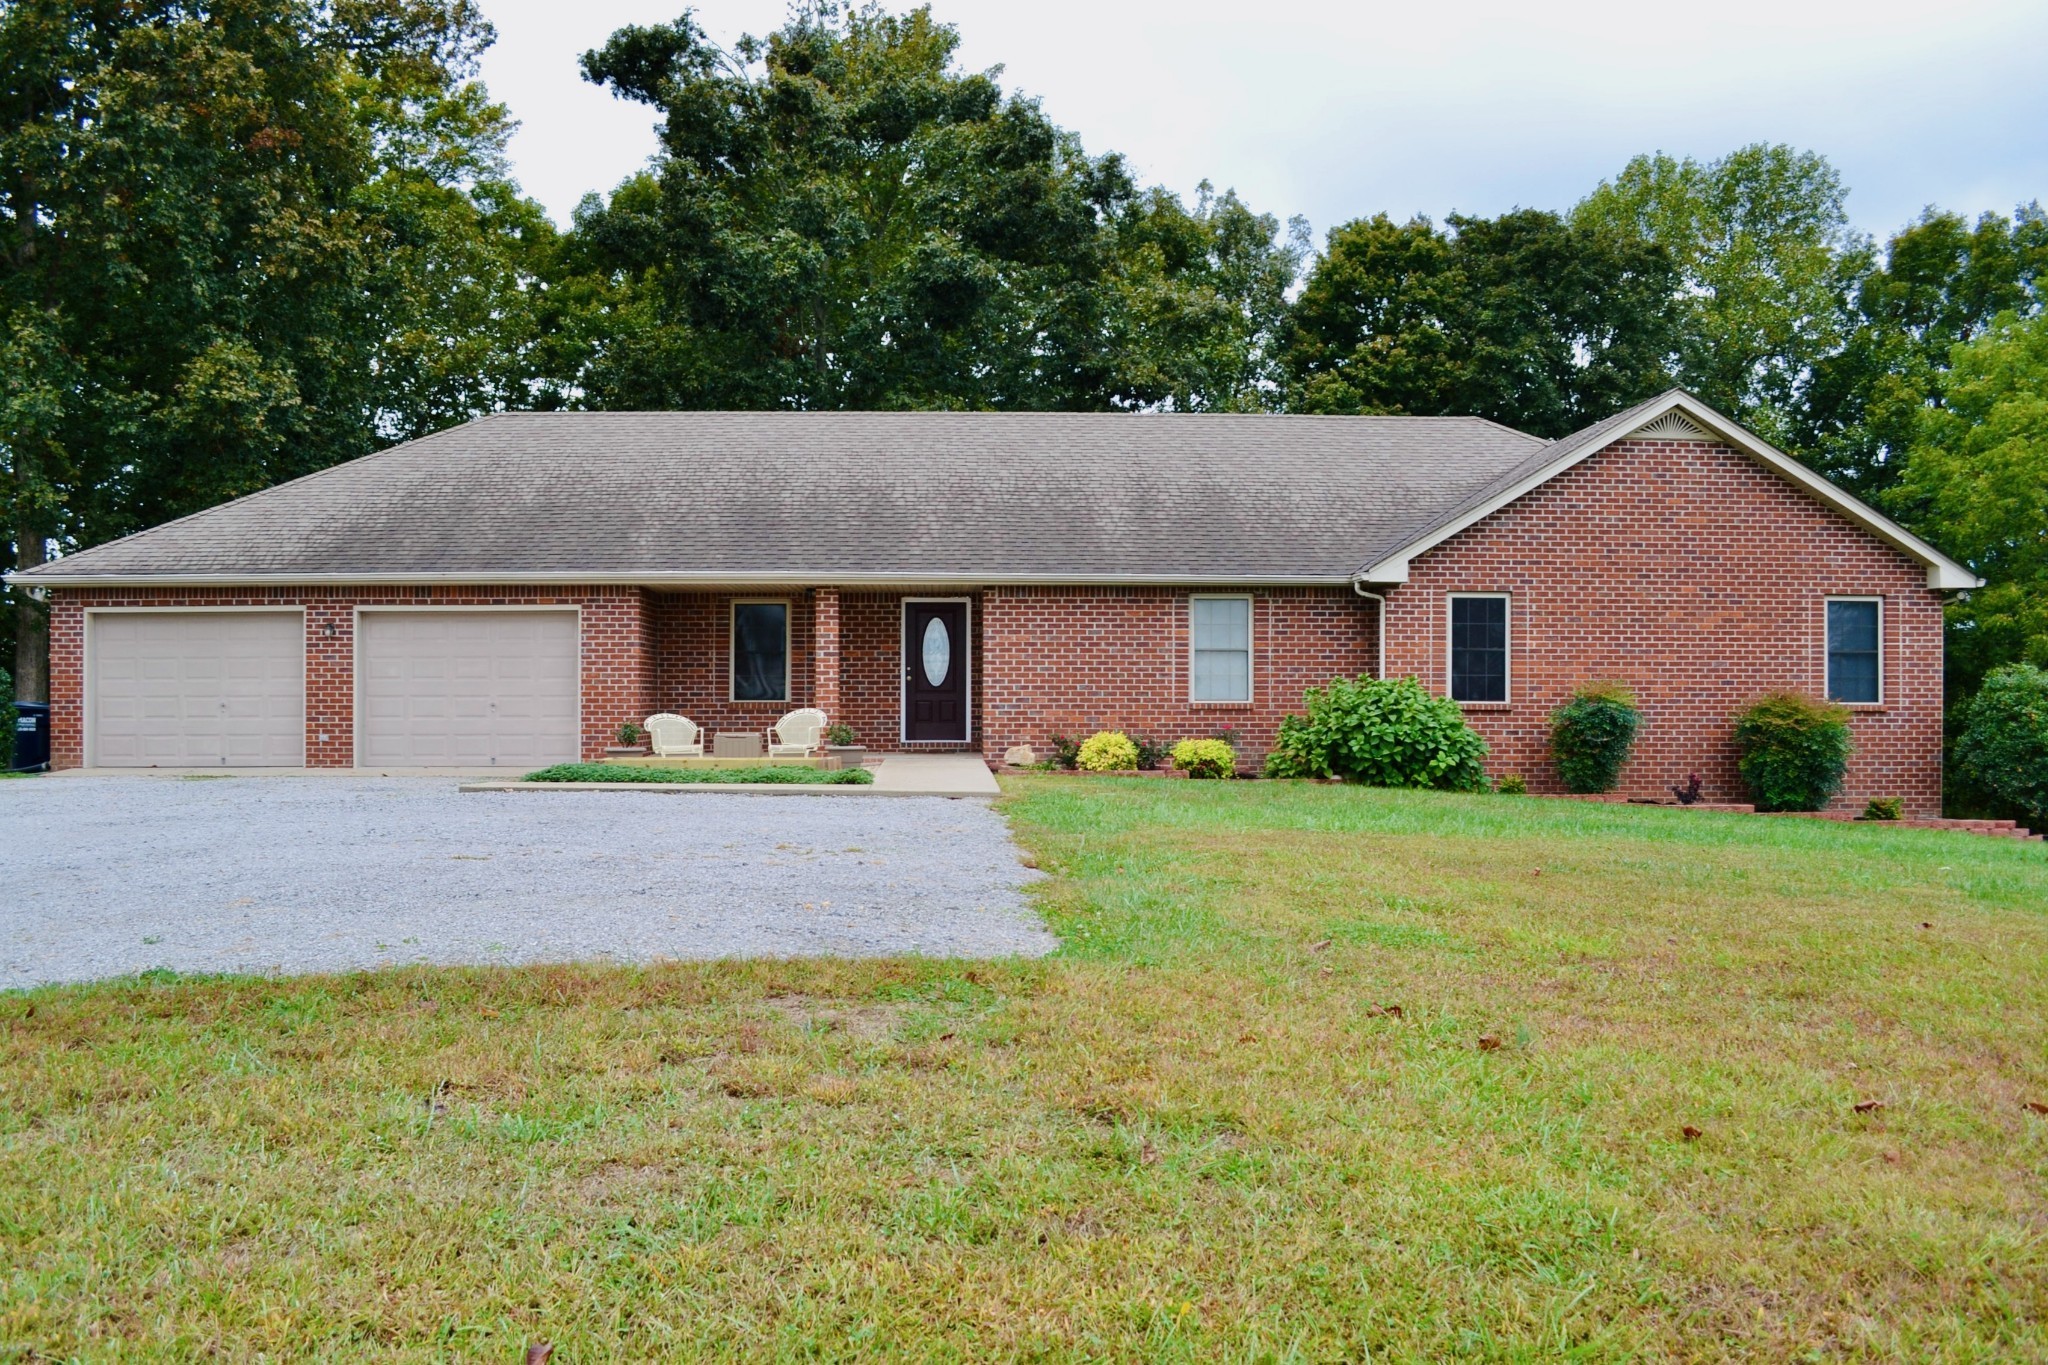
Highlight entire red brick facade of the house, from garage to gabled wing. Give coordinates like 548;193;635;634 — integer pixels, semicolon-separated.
36;431;1942;814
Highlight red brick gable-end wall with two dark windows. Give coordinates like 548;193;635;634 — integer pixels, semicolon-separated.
1386;440;1942;814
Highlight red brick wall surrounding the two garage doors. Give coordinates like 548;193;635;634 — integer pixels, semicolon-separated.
49;585;653;767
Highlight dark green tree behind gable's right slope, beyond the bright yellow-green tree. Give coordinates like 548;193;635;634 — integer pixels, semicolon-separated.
1792;205;2048;497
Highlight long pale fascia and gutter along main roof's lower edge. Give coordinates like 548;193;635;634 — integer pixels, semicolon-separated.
6;571;1376;591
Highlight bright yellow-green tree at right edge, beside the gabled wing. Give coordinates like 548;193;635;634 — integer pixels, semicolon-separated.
1886;313;2048;696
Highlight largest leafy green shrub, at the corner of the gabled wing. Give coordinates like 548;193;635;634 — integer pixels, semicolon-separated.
1266;677;1487;792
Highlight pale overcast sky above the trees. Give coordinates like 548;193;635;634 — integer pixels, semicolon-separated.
483;0;2048;239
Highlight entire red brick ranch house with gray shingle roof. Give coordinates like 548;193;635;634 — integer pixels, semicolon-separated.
14;391;1978;814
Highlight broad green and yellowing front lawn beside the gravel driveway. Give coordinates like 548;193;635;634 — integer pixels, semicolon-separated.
0;778;2048;1361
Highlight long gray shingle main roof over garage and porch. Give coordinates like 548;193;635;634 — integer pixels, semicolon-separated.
27;411;1544;585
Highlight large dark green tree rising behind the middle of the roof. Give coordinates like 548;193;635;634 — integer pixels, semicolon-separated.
561;2;1261;409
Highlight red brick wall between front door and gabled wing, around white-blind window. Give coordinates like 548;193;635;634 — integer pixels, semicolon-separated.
981;587;1378;761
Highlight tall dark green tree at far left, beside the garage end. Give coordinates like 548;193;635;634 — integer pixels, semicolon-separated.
0;0;552;696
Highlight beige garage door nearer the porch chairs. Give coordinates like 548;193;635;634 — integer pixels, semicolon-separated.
356;612;582;767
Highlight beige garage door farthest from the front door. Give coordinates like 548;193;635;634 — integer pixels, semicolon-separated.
86;612;305;767
